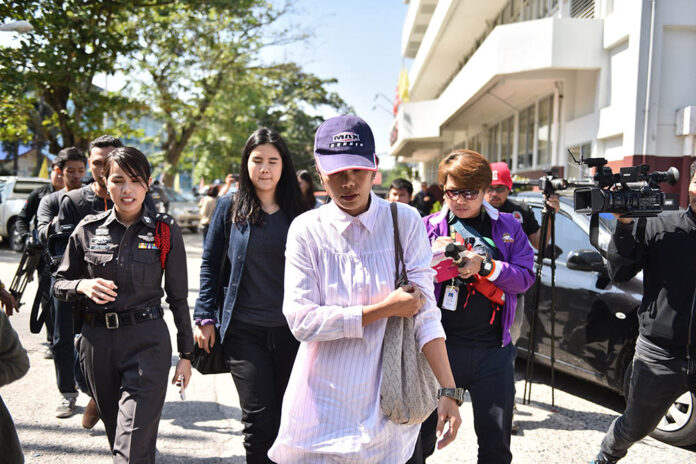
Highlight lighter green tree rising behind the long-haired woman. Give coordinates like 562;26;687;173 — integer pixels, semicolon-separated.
131;0;344;185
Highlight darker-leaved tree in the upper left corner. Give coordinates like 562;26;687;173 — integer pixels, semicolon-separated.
0;0;154;153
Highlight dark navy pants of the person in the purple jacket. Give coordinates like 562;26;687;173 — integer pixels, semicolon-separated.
409;343;517;464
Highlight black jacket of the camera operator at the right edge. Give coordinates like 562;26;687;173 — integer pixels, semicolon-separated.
608;209;696;355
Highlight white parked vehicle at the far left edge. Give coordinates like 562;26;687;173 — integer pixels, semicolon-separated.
0;176;50;251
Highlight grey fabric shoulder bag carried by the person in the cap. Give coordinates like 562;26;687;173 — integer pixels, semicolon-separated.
380;203;439;425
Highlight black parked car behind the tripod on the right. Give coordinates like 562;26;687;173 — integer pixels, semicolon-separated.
508;193;696;446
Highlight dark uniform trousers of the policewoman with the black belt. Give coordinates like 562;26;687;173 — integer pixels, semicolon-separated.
80;318;172;464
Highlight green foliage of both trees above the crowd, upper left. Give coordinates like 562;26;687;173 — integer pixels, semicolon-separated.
0;0;349;185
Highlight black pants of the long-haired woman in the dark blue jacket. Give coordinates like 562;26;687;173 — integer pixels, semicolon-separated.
224;320;300;464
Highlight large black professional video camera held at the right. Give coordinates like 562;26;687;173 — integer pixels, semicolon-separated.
574;158;679;217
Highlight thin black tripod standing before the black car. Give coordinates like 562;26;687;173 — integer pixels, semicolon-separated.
522;194;556;406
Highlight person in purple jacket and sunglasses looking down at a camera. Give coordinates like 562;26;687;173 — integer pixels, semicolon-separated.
421;150;534;464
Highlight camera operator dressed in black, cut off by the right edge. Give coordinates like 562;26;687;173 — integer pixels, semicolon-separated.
592;162;696;464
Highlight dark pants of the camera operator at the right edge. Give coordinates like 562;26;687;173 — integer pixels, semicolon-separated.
601;336;696;458
